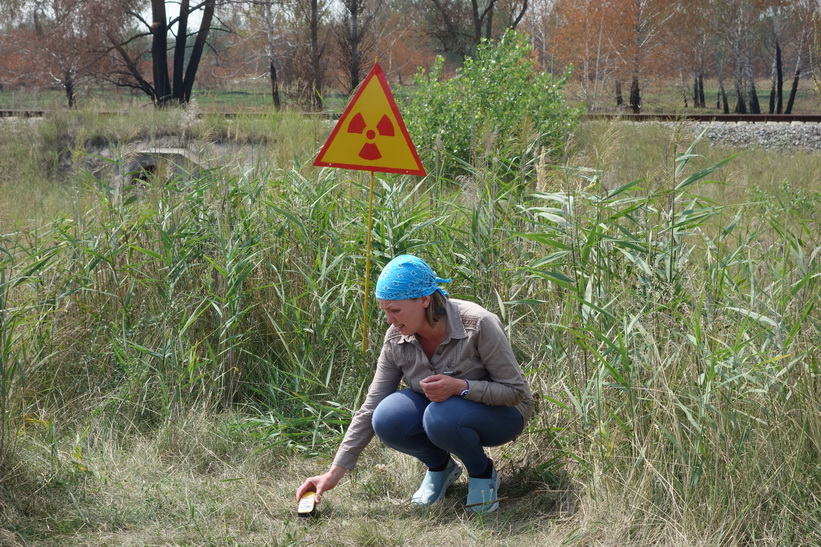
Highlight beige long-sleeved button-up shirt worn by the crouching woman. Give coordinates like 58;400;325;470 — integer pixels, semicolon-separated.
334;298;533;469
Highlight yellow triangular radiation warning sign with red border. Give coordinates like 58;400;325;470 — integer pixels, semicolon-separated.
314;63;427;176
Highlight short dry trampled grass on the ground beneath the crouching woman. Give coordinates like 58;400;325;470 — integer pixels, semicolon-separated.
3;414;578;545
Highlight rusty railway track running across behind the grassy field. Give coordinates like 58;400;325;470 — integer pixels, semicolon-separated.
0;109;821;123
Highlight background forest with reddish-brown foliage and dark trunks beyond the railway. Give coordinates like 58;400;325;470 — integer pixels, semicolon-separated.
0;0;819;113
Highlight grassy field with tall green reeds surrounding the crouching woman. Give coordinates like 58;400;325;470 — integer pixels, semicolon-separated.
0;111;821;546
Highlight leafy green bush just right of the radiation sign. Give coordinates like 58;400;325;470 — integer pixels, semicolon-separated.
405;32;580;177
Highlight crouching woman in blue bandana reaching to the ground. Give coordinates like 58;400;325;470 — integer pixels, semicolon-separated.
296;255;533;512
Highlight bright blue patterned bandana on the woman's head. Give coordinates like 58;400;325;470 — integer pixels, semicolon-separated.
376;255;450;300
